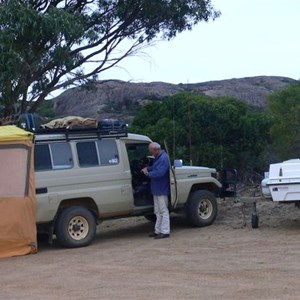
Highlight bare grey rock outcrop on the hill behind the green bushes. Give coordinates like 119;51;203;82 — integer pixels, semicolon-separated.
53;76;296;120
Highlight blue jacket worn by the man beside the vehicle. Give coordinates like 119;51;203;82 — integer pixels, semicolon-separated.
147;150;170;196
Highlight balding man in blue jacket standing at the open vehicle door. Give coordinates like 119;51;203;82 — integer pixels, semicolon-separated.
142;142;170;239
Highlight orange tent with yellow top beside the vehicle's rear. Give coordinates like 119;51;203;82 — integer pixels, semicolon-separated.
0;126;37;257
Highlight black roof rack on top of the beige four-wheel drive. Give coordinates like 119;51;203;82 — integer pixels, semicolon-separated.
35;119;128;142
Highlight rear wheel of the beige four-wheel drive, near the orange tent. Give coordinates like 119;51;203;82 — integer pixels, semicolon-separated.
55;206;96;248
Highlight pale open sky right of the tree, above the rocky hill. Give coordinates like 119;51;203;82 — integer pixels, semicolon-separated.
99;0;300;84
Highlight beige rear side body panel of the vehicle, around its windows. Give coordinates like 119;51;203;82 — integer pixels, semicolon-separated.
36;140;138;223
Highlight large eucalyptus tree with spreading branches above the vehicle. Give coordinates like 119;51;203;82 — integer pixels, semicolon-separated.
0;0;220;115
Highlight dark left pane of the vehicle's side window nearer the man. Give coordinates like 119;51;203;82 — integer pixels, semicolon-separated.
76;142;99;167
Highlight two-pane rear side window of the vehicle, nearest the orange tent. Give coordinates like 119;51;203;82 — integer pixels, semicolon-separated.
34;143;73;171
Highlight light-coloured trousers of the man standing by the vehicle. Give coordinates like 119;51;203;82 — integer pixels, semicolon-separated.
153;196;170;234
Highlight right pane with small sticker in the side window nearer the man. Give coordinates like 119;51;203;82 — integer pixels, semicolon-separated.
97;139;119;165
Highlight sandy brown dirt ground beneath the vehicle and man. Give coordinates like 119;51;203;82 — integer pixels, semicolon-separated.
0;196;300;300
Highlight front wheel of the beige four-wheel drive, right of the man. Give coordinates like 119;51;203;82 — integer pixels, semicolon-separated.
186;191;218;227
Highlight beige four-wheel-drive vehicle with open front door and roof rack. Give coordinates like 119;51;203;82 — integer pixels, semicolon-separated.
35;122;237;247
